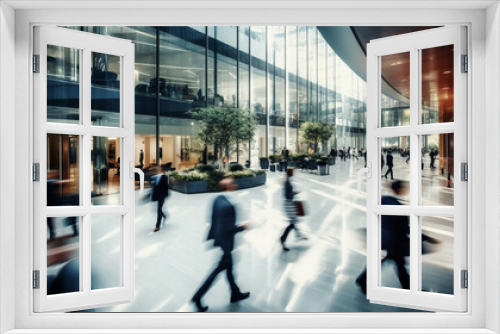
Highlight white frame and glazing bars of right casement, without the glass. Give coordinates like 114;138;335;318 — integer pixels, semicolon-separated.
366;25;469;312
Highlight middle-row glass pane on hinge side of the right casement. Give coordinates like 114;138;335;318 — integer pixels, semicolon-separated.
421;133;455;206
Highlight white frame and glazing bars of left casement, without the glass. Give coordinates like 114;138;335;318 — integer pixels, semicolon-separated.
33;26;135;312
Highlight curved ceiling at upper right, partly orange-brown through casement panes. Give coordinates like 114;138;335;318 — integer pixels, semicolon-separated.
318;26;453;120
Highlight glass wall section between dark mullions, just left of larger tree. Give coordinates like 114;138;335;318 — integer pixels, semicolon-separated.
160;27;207;169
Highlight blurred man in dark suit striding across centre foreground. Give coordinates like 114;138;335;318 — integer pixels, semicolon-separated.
191;178;250;312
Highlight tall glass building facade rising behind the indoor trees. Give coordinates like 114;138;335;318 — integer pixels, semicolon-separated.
60;26;408;187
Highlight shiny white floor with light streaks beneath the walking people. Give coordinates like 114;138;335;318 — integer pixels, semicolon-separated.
83;157;453;312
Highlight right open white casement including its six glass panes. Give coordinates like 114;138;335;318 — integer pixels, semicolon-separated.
367;27;467;311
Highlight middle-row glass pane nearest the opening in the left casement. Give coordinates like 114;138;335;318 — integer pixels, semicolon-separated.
90;136;121;205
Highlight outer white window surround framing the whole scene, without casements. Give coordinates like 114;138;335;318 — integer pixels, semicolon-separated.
0;1;500;333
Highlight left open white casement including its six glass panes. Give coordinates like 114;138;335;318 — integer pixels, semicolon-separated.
33;27;135;312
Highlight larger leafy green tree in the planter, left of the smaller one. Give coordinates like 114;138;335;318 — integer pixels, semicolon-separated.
189;105;257;170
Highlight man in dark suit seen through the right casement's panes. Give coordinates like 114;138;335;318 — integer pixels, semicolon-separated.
356;181;410;294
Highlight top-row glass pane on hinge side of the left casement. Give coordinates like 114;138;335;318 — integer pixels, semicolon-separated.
47;45;80;124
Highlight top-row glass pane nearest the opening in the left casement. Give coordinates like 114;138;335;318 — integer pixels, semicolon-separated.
91;52;121;127
